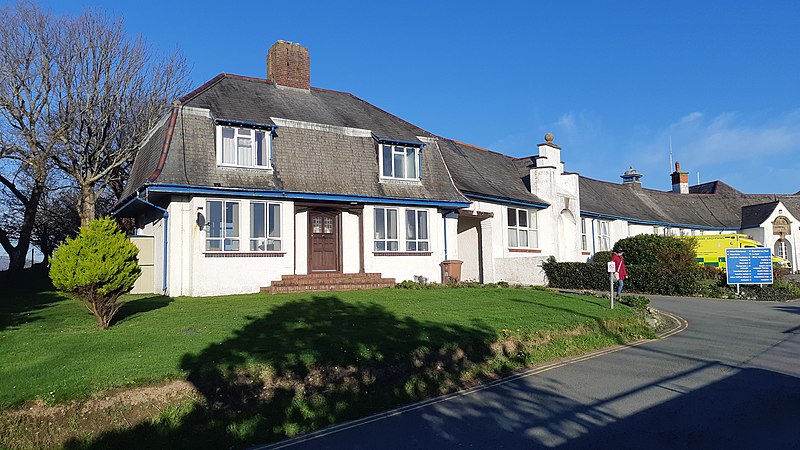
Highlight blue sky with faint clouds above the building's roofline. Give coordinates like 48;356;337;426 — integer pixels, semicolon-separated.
14;0;800;193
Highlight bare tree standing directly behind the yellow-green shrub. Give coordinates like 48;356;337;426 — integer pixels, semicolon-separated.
55;10;188;225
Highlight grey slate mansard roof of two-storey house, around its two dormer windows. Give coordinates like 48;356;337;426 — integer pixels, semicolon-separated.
124;74;467;203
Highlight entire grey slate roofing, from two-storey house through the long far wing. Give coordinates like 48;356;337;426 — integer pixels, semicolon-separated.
123;74;800;229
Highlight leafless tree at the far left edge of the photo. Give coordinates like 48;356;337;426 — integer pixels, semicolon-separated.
0;3;68;271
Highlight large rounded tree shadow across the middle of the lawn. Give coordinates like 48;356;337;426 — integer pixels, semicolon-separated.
66;296;496;449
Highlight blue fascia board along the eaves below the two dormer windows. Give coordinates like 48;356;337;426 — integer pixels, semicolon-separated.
147;184;469;209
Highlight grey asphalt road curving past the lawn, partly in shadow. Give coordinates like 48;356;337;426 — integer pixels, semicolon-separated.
258;297;800;449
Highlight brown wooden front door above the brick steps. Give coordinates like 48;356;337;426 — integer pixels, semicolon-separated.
308;210;342;272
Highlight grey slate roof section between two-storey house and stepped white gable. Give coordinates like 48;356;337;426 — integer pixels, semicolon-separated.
439;139;548;206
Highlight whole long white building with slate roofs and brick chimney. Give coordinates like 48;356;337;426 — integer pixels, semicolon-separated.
115;41;800;296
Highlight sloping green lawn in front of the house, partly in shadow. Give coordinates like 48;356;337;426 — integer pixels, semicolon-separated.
0;288;652;448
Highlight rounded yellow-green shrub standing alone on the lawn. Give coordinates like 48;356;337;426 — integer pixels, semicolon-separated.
50;217;141;329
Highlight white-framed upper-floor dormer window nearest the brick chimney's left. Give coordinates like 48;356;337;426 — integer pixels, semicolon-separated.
217;126;272;169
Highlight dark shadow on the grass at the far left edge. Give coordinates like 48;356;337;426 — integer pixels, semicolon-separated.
0;264;65;331
